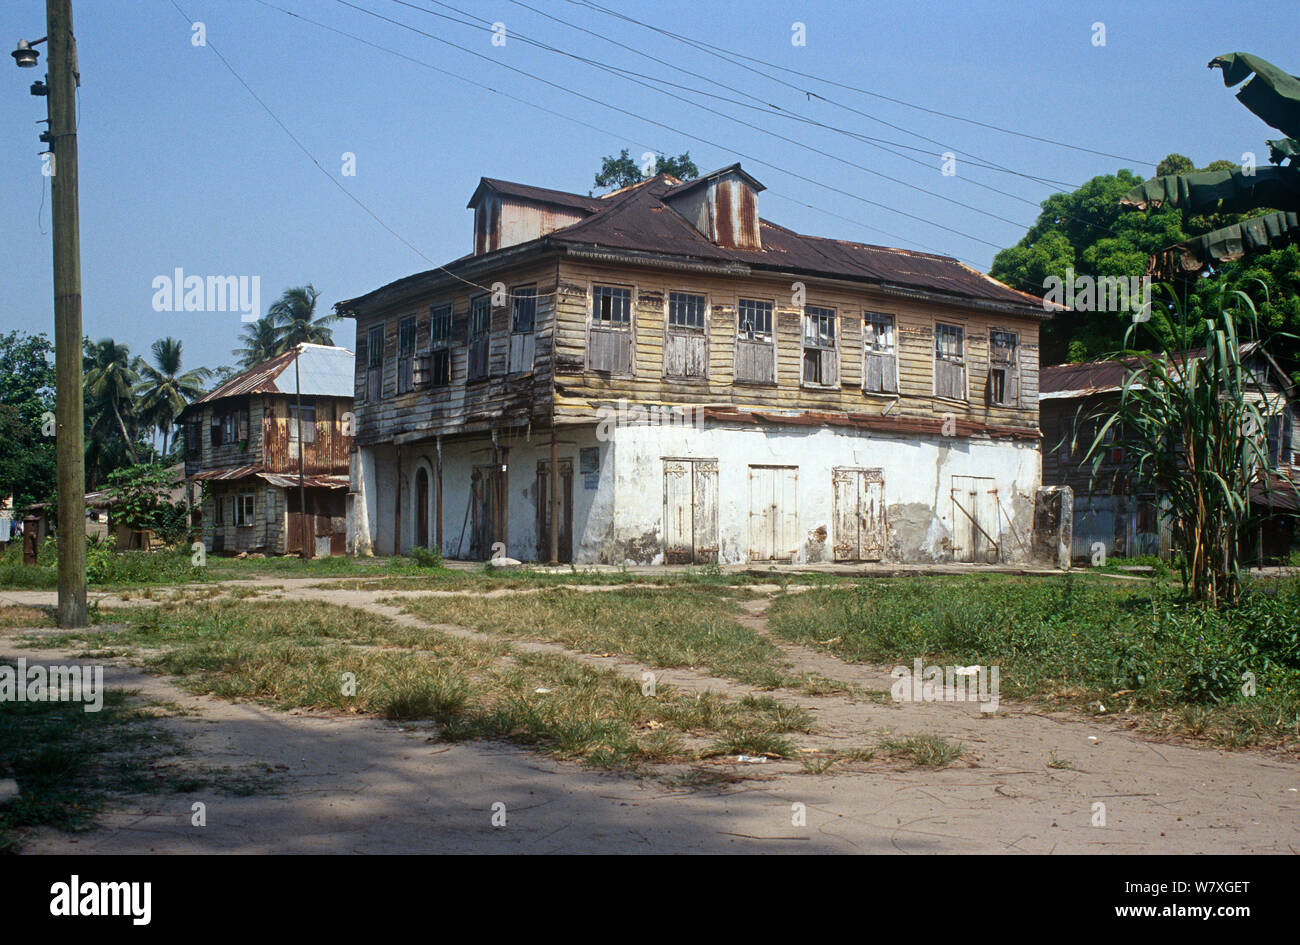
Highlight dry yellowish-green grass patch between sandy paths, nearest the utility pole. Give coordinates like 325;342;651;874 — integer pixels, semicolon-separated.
83;601;811;768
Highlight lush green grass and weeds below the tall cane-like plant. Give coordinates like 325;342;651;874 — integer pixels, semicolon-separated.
770;576;1300;746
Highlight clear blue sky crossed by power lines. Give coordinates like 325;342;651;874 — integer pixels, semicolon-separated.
0;0;1300;376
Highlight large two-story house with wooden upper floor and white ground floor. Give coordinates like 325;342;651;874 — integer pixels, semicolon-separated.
335;165;1045;564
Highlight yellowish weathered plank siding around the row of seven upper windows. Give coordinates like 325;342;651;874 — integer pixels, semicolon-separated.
555;260;1039;430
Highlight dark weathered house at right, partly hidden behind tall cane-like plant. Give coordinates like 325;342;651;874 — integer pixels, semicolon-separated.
1039;343;1300;560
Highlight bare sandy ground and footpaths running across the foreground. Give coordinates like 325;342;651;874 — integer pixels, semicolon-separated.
0;580;1300;854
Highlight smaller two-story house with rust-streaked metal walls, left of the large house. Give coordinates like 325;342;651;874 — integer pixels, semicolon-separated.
179;344;354;555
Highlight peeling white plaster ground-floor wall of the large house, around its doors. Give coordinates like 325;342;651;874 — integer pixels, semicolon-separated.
358;422;1041;564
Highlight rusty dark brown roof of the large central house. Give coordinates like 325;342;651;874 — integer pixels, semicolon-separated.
335;165;1049;317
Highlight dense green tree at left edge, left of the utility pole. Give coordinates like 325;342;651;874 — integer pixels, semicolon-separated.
0;331;55;510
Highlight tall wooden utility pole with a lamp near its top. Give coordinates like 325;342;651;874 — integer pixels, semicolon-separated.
46;0;87;628
